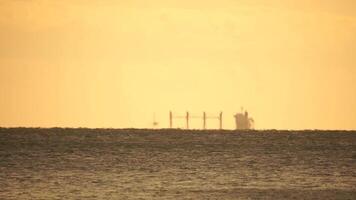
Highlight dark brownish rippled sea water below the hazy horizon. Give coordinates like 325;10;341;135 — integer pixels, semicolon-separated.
0;129;356;199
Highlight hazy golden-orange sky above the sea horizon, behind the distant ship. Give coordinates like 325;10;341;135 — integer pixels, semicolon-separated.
0;0;356;129
